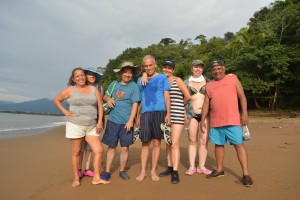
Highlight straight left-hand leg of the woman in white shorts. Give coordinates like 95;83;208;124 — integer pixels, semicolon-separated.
71;138;83;187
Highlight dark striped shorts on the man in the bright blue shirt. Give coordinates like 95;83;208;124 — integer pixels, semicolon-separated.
140;111;166;142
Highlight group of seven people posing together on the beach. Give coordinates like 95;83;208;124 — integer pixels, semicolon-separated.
54;55;253;187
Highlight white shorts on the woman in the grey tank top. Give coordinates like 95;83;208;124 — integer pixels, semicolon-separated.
66;122;100;139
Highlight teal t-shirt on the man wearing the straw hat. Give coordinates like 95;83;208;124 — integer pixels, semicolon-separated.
107;81;141;124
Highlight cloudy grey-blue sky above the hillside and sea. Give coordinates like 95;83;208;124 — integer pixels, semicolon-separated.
0;0;274;102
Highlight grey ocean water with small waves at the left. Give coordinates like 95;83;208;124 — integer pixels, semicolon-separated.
0;113;66;139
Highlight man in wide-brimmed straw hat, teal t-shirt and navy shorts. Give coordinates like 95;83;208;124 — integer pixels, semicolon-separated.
102;62;141;180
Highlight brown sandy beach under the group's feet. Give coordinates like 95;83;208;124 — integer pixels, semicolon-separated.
0;117;300;200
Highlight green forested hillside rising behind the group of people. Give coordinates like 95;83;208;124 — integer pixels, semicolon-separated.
101;0;300;110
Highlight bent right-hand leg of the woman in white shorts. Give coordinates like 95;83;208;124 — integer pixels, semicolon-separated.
85;135;110;184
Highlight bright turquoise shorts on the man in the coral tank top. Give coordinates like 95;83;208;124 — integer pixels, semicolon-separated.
209;126;244;145
